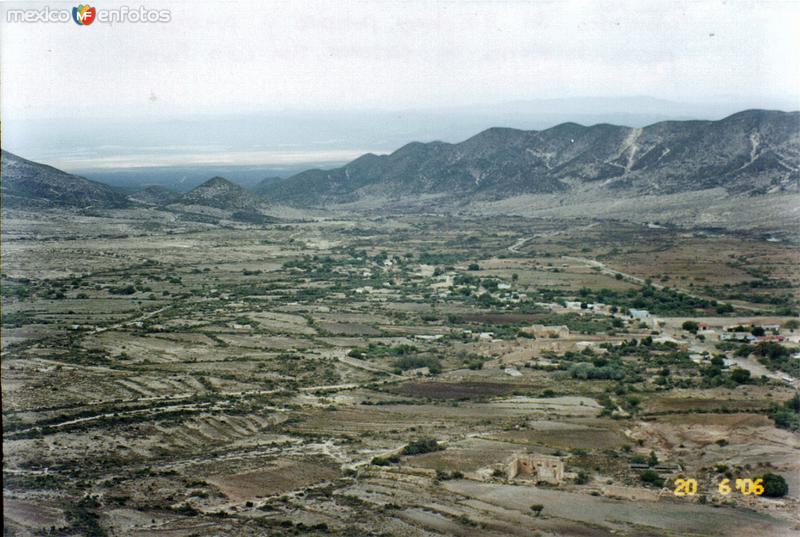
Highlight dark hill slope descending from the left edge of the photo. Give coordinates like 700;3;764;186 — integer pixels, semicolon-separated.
0;150;130;208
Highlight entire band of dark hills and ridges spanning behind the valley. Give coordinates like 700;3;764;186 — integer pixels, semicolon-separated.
1;110;800;227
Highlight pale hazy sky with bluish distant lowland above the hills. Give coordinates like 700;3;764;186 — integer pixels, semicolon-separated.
0;2;800;180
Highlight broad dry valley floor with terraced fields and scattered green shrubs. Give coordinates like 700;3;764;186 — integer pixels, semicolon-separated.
2;210;800;537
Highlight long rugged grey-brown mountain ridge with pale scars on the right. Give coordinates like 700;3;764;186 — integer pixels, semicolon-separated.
258;110;800;205
